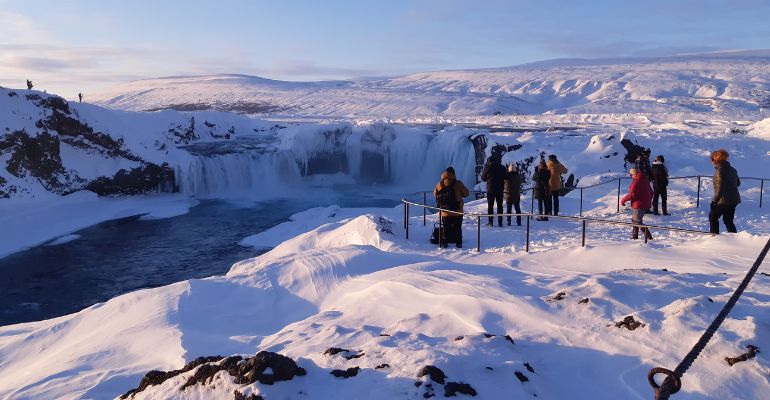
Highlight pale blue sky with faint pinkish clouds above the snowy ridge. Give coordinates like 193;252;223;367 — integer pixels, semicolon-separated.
0;0;770;98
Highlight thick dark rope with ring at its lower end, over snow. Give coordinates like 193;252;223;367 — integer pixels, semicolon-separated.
647;239;770;400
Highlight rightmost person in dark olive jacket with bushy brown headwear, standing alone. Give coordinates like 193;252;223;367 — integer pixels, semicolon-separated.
709;149;741;233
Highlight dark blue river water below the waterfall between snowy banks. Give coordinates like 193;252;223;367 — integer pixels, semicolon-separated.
0;190;398;325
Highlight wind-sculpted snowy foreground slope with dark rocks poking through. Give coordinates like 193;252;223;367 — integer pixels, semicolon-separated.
0;206;770;399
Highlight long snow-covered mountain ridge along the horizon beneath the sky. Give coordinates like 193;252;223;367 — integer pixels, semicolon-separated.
89;52;770;119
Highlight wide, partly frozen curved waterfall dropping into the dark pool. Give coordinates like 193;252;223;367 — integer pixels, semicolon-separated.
175;125;483;198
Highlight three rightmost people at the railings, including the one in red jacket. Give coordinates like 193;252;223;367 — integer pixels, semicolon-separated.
620;149;741;240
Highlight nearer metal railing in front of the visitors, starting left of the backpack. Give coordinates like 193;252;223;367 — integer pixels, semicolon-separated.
401;199;716;252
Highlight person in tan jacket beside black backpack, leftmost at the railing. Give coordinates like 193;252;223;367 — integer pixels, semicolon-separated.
433;167;470;248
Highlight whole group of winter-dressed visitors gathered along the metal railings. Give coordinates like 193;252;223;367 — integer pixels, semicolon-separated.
433;149;741;248
